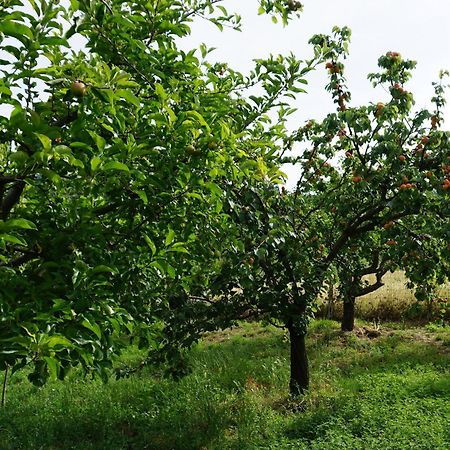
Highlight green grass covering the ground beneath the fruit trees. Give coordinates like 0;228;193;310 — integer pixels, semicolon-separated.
0;321;450;450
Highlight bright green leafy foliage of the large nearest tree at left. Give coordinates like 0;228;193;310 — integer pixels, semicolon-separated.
0;0;313;384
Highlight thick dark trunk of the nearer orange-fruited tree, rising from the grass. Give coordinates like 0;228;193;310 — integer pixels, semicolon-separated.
288;325;309;397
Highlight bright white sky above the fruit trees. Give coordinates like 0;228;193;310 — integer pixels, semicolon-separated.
182;0;450;187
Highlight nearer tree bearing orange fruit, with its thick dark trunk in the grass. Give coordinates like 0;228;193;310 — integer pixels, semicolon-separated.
155;28;450;396
